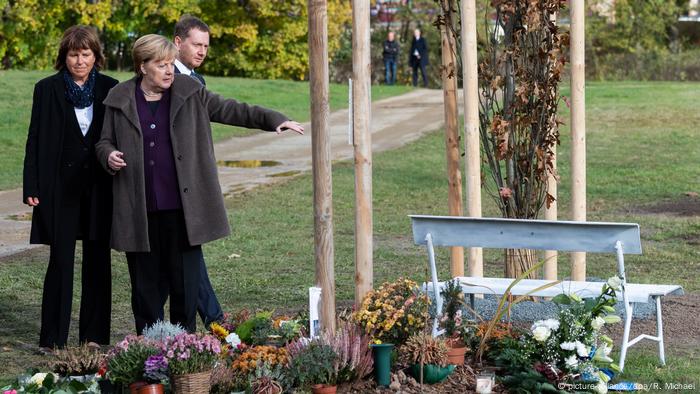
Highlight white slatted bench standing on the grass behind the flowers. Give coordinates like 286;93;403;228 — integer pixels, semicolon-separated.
410;215;683;369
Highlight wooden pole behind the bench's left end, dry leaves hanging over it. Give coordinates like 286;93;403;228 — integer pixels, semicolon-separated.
442;0;464;277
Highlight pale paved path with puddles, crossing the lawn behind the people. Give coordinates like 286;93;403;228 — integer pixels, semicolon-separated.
0;89;454;257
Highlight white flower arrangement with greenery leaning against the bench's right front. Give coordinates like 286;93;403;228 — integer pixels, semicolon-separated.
496;277;621;392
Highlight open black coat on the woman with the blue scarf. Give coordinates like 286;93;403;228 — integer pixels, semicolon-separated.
22;72;118;245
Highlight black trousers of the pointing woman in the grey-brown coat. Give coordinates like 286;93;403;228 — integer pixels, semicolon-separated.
126;210;202;335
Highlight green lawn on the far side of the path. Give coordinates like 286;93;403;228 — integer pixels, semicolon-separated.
0;71;410;190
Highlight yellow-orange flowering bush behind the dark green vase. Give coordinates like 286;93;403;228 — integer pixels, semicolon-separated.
353;278;429;345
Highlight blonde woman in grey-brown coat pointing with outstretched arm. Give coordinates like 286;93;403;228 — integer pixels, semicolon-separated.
96;34;304;334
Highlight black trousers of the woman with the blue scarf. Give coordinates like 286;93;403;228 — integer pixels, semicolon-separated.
39;185;112;347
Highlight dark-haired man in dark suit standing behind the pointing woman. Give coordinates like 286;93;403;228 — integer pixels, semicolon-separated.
170;15;224;328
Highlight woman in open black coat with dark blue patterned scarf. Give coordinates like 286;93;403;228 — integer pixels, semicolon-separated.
23;26;118;350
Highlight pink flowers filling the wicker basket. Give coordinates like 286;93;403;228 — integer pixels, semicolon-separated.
162;333;221;375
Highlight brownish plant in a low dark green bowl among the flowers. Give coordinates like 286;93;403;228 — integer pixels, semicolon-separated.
399;334;455;384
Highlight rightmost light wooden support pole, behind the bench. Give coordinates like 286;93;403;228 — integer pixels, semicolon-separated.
571;0;586;280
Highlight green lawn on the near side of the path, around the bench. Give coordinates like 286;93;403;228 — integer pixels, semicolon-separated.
0;81;700;383
